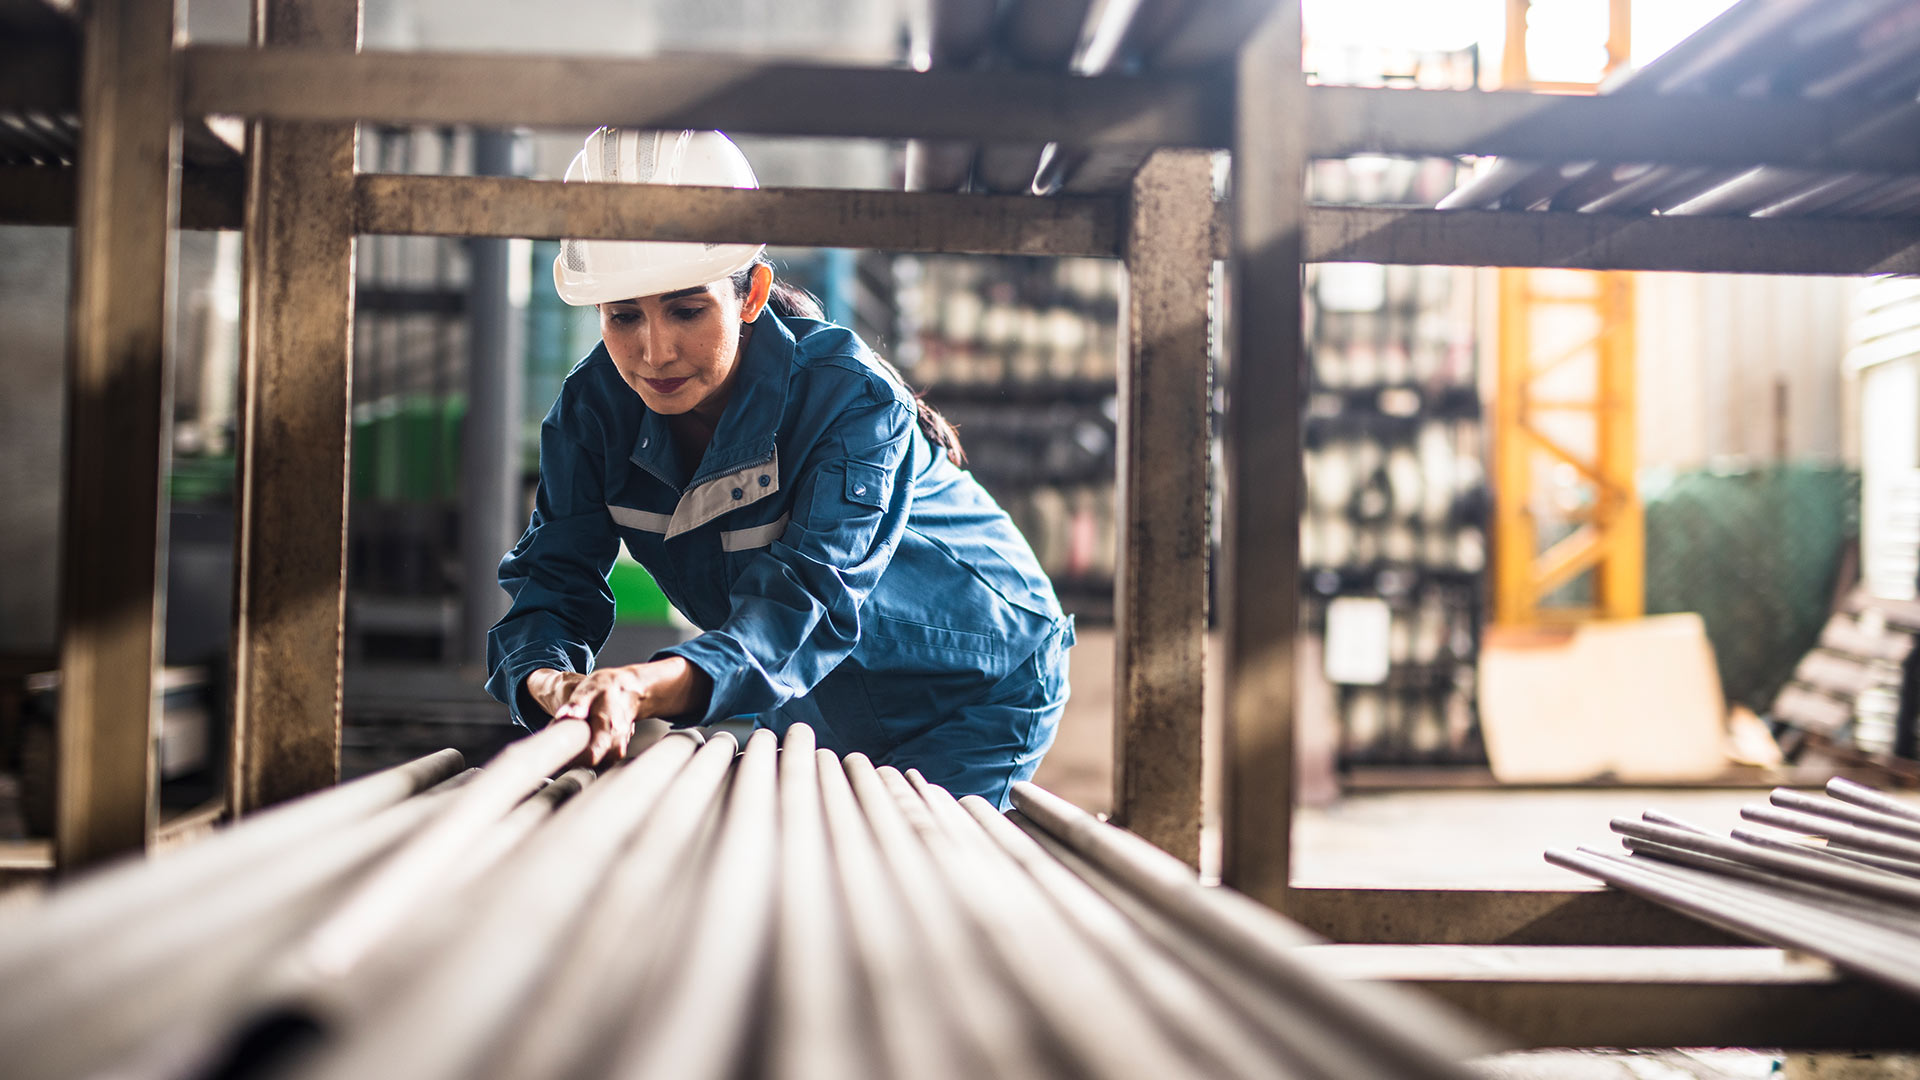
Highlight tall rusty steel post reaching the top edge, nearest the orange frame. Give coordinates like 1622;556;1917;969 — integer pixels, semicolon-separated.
1219;0;1308;909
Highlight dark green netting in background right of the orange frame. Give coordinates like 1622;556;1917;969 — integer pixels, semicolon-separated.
1642;463;1860;711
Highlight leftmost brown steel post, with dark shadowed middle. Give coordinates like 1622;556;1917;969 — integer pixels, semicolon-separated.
54;0;180;869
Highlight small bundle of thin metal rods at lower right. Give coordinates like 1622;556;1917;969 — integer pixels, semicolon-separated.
1546;778;1920;995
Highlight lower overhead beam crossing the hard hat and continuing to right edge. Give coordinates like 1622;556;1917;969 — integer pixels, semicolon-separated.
355;175;1920;275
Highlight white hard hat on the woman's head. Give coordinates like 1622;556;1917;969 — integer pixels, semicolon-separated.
553;127;764;307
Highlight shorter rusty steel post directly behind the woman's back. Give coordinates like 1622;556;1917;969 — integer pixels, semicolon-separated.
1114;150;1213;867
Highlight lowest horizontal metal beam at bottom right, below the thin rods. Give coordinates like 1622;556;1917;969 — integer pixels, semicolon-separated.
1304;945;1920;1049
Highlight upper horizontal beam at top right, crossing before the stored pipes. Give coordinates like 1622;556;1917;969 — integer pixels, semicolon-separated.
1308;86;1920;173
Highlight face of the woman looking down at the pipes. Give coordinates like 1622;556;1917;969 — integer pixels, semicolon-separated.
599;279;751;417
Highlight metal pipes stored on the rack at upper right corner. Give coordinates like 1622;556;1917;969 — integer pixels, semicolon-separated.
1440;0;1920;217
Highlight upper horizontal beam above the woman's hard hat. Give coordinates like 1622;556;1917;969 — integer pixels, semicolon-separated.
182;46;1229;146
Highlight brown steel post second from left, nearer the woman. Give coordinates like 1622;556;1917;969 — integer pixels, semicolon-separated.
232;0;361;813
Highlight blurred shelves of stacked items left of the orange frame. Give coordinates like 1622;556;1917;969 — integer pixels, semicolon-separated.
1300;160;1488;765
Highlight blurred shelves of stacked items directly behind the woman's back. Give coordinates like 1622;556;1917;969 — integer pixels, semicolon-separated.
893;256;1119;621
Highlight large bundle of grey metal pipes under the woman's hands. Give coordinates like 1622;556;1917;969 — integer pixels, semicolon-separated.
0;723;1490;1080
